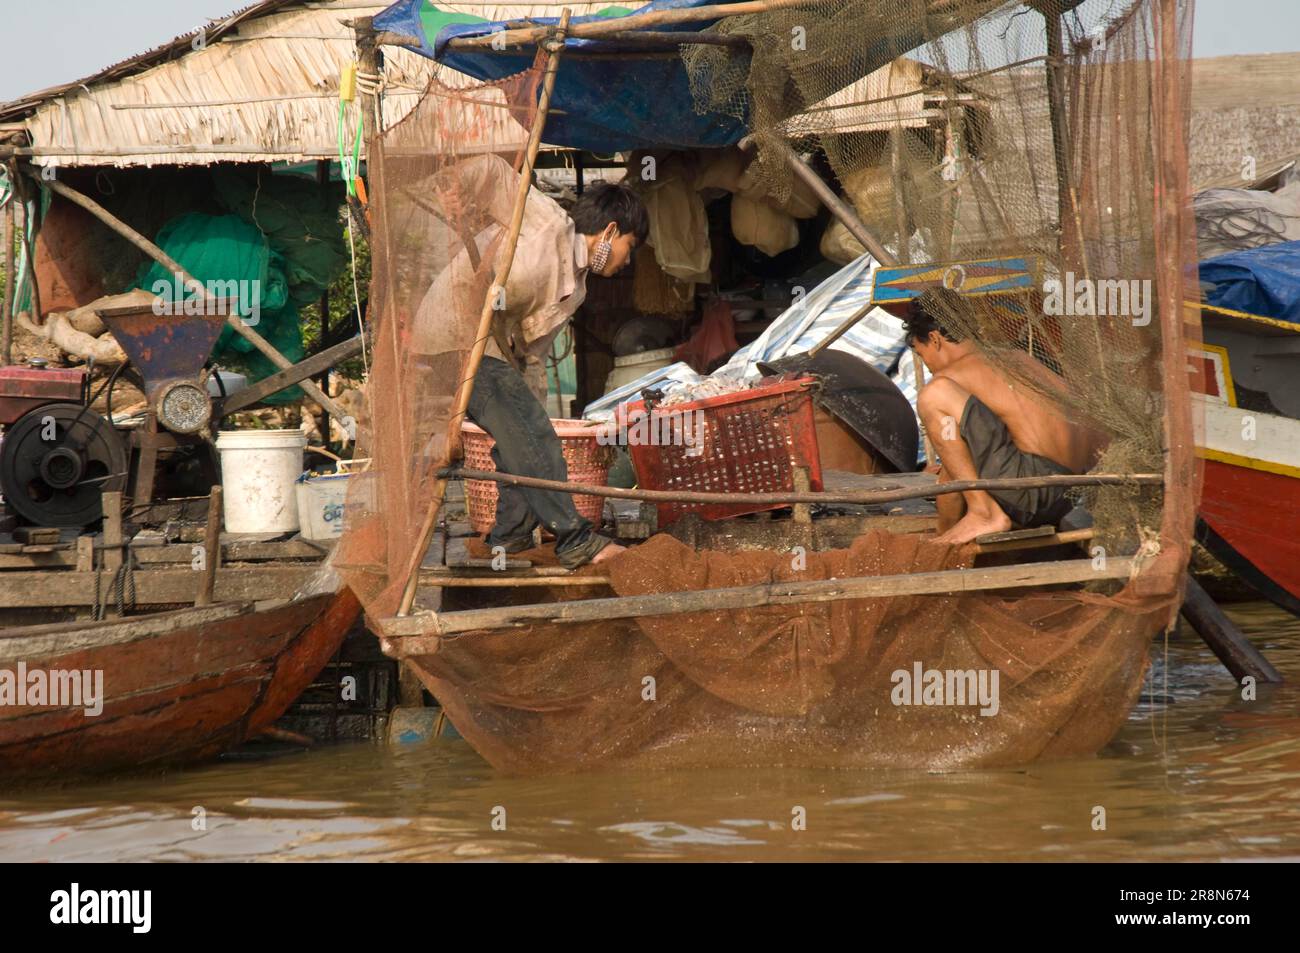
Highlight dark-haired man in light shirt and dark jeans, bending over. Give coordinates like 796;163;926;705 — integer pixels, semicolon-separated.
412;155;650;569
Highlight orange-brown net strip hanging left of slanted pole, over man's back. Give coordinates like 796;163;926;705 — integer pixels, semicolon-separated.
335;59;541;618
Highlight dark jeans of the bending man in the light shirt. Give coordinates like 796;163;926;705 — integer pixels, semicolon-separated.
468;356;608;568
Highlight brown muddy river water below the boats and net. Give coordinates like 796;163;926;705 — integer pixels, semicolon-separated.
0;605;1300;861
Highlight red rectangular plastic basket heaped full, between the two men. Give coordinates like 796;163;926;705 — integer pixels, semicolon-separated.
620;377;822;527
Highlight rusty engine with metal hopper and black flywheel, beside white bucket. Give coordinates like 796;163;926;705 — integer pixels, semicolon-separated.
0;306;226;528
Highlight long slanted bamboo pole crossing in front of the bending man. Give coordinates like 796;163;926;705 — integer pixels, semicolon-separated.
398;7;569;615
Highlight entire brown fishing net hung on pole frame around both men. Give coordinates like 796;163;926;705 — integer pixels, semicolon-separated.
337;0;1196;771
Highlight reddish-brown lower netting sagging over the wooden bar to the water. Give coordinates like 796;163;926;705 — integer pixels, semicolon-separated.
395;530;1177;774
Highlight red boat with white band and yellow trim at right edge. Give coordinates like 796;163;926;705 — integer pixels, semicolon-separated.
1192;306;1300;615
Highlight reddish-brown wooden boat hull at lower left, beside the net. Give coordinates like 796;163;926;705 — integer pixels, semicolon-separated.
0;588;360;780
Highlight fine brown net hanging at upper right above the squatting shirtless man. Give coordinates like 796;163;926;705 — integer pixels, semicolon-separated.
684;0;1195;551
